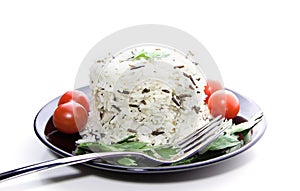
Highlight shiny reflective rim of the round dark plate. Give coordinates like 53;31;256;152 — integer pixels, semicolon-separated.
33;86;267;173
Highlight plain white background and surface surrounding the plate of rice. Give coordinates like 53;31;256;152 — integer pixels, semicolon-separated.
0;0;300;191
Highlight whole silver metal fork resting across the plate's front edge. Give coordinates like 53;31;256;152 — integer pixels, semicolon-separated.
0;116;230;182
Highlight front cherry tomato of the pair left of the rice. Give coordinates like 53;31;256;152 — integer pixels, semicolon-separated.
53;101;88;134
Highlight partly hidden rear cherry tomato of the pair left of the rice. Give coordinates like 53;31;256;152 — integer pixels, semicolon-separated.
58;90;90;112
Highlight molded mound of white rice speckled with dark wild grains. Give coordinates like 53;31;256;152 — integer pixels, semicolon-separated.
78;45;211;145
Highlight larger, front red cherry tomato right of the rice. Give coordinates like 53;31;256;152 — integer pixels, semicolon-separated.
208;90;240;119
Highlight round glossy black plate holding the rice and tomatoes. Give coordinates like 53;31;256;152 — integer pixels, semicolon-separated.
34;87;267;173
